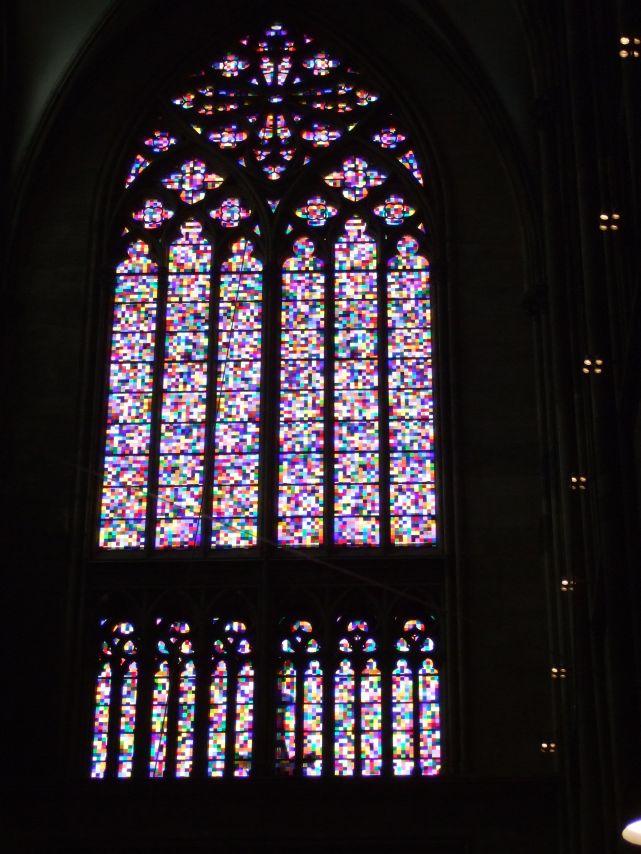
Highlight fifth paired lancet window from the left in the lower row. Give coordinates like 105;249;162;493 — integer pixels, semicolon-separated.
334;620;383;777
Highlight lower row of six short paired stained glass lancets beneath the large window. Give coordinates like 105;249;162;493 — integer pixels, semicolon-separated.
91;618;441;779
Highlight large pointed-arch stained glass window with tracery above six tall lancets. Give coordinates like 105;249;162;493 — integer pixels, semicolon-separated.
99;24;437;553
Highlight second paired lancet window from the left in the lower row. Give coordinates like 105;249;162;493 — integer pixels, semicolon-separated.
149;618;196;777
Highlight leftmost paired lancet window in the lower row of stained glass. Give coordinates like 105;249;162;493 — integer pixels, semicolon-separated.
91;619;138;780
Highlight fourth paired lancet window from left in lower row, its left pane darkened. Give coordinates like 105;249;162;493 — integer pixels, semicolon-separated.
276;620;323;777
